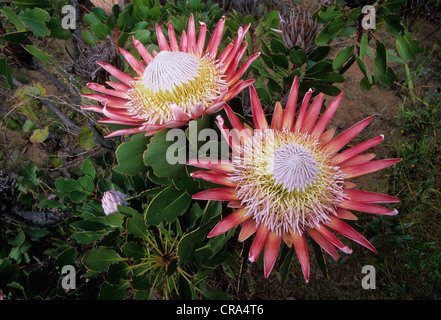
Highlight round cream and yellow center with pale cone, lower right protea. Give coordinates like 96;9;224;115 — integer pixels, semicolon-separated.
229;129;344;234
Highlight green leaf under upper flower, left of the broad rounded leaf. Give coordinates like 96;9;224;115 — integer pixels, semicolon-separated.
114;133;150;176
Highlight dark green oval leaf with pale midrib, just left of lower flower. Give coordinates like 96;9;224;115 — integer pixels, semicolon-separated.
145;186;191;225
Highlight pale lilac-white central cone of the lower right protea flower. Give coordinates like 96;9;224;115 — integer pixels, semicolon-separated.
270;143;320;192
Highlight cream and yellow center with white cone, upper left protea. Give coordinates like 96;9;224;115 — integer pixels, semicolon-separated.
127;51;228;125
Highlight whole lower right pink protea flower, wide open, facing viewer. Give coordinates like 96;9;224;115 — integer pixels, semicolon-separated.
189;78;401;282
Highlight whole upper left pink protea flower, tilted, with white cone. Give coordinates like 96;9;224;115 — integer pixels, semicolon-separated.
83;15;259;137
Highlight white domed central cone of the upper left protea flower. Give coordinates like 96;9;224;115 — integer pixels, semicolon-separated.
142;51;201;93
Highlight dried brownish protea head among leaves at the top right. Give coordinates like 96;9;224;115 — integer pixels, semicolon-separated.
274;7;322;53
